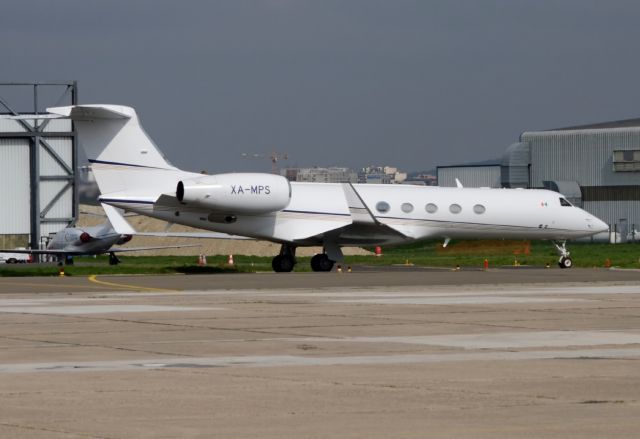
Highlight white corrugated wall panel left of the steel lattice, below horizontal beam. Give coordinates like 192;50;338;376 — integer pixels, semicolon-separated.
0;139;30;235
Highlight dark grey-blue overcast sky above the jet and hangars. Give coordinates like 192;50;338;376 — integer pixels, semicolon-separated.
0;0;640;172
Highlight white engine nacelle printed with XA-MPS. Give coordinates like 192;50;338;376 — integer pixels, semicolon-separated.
176;173;291;213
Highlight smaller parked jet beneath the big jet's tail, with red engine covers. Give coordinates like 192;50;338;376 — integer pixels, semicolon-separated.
0;221;199;265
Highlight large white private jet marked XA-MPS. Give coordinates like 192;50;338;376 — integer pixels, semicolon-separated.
10;105;608;272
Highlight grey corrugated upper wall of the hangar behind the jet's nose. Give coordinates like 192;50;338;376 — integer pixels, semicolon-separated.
522;127;640;187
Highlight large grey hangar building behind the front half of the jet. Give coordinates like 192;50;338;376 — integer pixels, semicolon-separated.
438;118;640;241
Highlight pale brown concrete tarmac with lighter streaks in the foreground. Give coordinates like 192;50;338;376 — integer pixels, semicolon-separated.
0;267;640;438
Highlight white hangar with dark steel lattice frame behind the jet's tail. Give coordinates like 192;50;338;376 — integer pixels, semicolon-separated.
0;81;78;254
